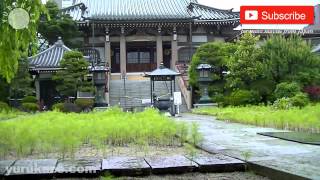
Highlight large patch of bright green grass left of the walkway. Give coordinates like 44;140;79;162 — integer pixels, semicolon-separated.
0;108;198;157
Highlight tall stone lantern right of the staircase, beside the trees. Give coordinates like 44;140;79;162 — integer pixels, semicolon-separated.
197;64;213;104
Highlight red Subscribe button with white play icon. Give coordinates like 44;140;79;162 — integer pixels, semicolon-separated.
240;6;314;24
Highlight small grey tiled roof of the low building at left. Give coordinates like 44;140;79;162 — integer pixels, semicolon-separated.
28;39;71;70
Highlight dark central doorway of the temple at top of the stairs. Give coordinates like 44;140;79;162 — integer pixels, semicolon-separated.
127;42;157;72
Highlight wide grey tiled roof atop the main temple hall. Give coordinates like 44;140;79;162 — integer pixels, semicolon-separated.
63;0;239;22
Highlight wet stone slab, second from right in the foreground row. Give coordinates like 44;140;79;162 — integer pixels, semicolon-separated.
145;155;198;174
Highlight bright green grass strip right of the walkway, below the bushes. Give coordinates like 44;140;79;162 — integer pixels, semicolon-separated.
193;105;320;133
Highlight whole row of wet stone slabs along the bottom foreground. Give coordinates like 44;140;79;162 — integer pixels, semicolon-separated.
0;154;245;179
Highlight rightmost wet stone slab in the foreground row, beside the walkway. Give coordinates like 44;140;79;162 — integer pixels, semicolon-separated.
189;154;245;173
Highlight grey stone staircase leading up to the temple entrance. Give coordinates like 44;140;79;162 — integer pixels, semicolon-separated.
109;78;188;112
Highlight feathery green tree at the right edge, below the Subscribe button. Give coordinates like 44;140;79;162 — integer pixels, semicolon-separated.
261;35;320;85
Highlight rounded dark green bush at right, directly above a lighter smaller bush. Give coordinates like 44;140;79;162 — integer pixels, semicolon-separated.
274;82;301;99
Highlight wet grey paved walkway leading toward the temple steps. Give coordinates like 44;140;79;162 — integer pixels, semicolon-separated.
177;114;320;179
